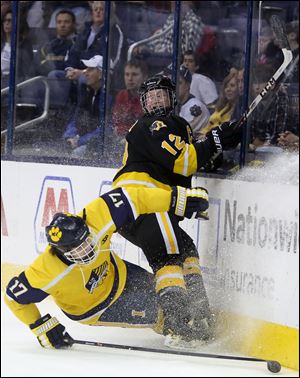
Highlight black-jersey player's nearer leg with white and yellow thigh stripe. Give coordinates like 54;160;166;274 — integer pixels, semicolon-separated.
121;213;205;339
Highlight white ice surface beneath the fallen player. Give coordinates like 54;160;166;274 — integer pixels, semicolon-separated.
1;299;299;377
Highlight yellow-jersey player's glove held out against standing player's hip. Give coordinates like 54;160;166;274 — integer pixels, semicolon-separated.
171;186;209;219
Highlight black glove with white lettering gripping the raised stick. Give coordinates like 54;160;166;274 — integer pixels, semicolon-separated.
206;122;242;152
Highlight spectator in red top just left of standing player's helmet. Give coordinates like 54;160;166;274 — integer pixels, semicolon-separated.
112;60;148;140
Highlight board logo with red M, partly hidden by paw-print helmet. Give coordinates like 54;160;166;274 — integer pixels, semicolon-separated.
34;176;76;254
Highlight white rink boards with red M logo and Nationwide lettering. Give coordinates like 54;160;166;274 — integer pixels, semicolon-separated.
1;161;299;328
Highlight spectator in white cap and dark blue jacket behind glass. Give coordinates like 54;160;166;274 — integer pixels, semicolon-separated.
63;55;103;157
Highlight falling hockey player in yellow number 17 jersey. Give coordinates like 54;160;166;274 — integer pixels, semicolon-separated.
4;186;208;348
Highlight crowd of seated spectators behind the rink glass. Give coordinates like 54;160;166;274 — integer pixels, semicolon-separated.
1;1;299;175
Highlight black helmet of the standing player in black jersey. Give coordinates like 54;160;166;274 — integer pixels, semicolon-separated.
139;75;177;116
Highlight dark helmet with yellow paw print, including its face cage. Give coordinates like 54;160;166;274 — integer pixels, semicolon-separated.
45;211;97;264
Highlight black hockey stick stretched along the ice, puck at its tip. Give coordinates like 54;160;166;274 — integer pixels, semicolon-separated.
66;338;281;373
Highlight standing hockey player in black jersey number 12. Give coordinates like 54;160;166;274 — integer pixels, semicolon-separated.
113;75;241;341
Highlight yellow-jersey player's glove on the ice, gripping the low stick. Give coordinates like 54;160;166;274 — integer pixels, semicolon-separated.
29;314;71;349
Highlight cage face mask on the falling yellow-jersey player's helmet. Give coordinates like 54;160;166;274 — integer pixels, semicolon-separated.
63;231;99;265
